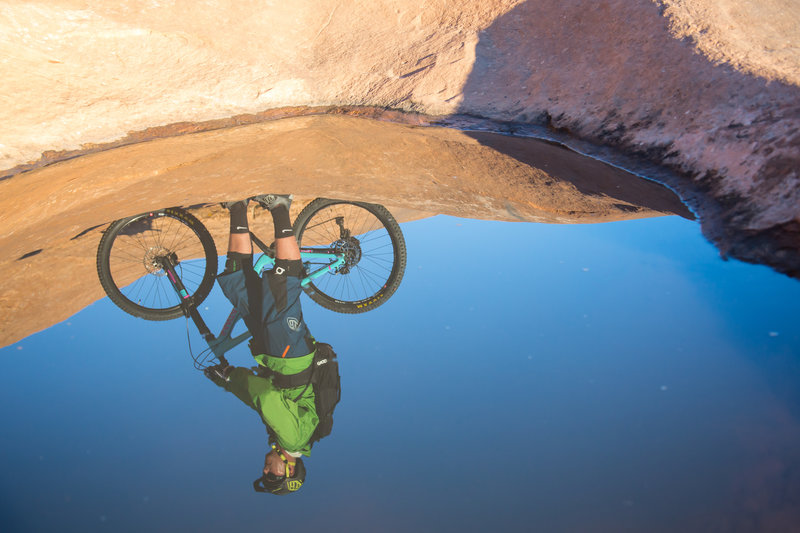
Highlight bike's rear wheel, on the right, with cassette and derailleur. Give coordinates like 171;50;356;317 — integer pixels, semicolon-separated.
294;198;406;314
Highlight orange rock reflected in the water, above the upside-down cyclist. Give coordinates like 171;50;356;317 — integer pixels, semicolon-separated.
0;115;691;346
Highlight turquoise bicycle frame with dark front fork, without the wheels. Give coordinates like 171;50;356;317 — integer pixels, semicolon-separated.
162;243;345;363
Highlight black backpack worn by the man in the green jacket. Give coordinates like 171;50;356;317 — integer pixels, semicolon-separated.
266;342;342;444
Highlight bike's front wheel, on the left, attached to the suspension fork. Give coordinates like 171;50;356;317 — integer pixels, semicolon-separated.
97;207;217;320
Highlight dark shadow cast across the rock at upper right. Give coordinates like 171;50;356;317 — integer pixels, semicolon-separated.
461;0;800;277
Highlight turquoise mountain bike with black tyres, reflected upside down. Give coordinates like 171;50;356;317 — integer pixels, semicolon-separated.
97;198;406;364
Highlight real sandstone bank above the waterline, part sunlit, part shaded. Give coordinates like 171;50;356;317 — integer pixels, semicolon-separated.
0;0;800;275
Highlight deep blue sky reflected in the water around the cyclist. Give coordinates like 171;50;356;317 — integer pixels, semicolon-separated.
0;216;800;531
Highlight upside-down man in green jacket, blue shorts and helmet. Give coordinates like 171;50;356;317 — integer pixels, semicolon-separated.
206;194;319;494
